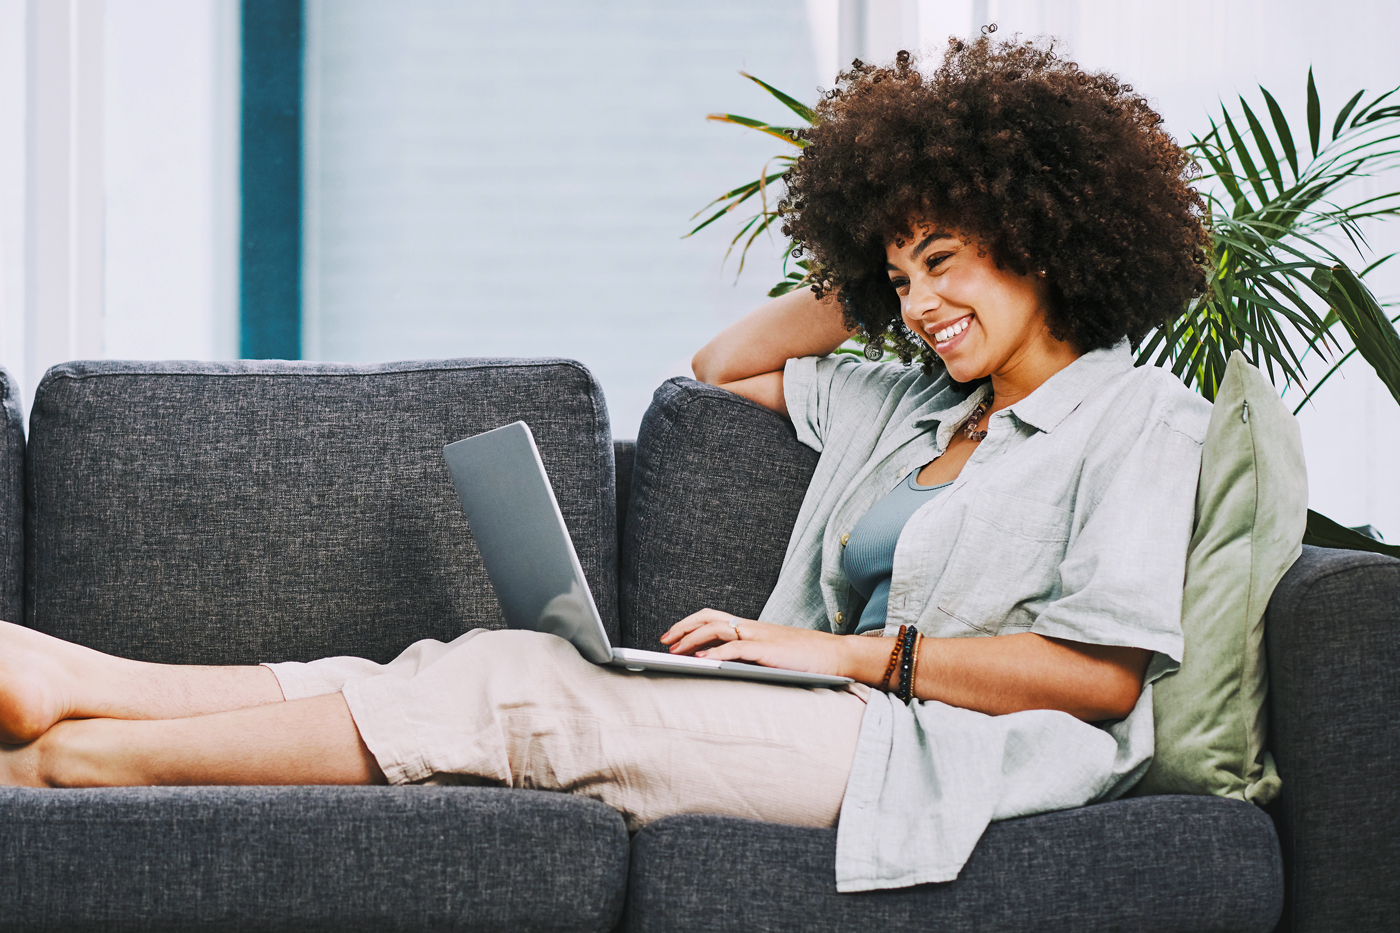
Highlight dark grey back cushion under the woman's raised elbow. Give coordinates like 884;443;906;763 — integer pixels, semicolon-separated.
619;378;816;649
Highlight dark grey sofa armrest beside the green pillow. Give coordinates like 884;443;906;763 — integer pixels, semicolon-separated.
1264;548;1400;933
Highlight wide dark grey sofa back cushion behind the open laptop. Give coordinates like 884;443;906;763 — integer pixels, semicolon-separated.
27;360;617;664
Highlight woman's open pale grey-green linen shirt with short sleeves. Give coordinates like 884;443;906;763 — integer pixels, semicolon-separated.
759;343;1210;891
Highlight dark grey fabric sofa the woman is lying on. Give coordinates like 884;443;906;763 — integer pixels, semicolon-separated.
0;360;1400;933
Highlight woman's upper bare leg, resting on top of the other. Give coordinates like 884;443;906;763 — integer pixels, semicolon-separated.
0;622;283;744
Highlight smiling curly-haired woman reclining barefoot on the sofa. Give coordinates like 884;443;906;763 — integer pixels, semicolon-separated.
0;39;1208;891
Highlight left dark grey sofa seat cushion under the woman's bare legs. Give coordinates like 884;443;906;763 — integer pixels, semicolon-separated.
0;787;627;933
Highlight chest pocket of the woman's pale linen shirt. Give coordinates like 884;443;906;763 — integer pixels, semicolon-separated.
923;492;1071;637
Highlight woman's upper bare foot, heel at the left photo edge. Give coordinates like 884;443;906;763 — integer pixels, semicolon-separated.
0;622;71;745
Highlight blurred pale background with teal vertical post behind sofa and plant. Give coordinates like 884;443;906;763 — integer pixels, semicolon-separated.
0;0;1400;542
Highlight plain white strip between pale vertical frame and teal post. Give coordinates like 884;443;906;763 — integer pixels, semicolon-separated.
104;0;239;360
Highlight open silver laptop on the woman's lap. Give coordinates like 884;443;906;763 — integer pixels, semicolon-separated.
442;422;851;686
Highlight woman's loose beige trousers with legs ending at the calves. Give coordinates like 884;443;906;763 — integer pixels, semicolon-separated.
267;629;869;829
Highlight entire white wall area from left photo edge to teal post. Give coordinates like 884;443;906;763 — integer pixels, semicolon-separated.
0;0;238;408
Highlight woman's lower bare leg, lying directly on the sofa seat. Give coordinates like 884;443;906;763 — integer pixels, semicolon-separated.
0;693;385;787
